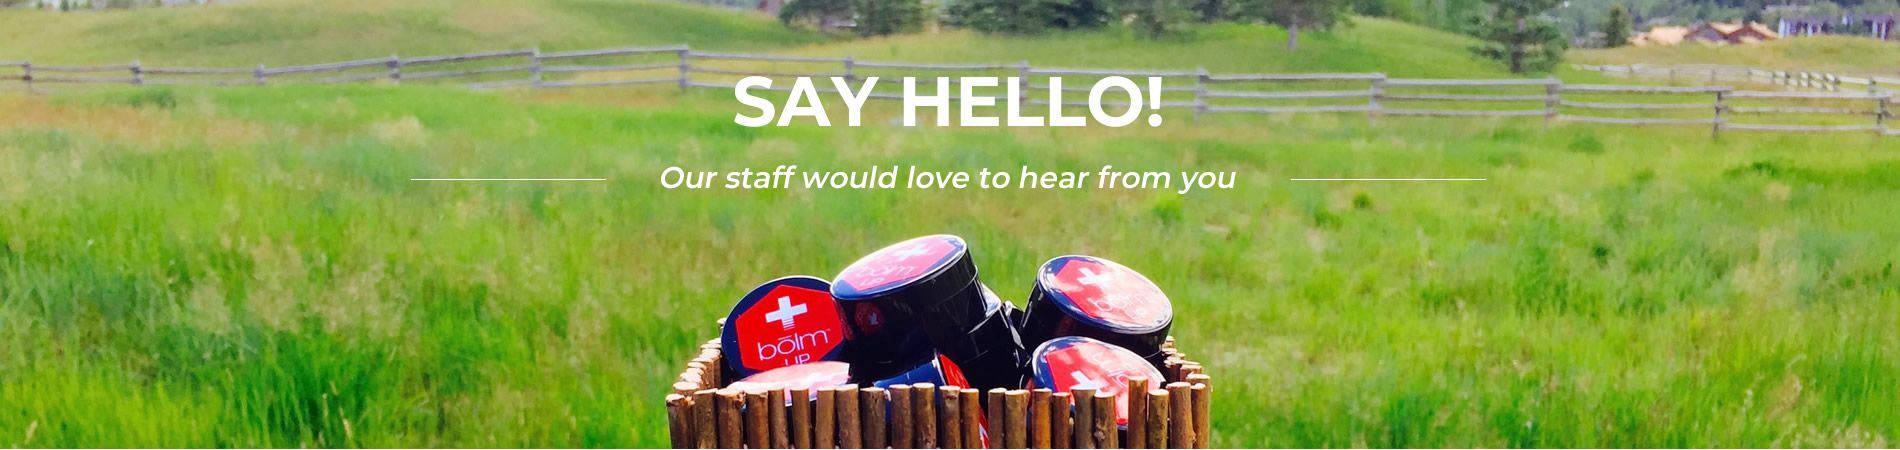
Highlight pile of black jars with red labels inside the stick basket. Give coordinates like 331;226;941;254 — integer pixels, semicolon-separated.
722;235;1174;427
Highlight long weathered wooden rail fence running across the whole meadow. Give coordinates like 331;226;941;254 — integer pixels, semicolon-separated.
0;46;1900;135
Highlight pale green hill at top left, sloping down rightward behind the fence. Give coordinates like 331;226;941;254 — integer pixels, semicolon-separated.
0;0;828;66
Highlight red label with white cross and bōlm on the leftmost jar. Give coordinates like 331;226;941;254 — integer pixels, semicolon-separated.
728;285;846;370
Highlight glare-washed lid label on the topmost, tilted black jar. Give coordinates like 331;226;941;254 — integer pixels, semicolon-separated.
832;234;963;298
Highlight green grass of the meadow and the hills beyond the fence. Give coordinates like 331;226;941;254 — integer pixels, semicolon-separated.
0;0;1900;446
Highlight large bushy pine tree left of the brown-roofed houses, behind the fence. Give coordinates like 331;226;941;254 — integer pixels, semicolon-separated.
1473;0;1569;74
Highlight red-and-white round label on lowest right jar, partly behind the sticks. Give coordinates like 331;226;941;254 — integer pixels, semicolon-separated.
1041;338;1165;425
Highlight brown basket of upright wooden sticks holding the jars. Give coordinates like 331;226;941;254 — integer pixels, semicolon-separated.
667;324;1212;448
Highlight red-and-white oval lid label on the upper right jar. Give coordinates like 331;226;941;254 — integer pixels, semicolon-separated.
1041;256;1174;328
